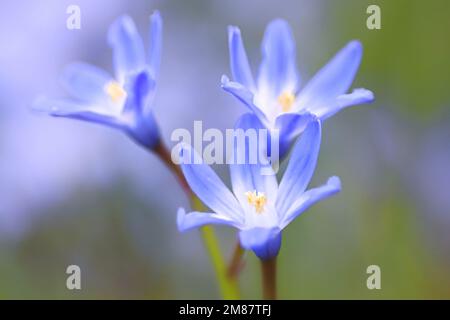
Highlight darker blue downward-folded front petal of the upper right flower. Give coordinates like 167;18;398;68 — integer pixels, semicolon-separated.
275;112;317;159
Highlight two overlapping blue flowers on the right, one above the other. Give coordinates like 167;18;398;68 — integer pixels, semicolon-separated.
177;19;374;259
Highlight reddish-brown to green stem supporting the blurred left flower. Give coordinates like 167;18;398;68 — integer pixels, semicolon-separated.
153;142;239;300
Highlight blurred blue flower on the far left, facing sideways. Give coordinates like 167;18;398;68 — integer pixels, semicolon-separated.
33;12;162;148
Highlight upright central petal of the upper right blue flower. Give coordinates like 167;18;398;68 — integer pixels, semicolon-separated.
258;19;299;98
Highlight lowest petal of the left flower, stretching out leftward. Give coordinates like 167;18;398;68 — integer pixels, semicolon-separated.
33;97;126;129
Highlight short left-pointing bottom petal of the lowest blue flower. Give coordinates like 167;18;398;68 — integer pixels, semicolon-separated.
177;208;241;232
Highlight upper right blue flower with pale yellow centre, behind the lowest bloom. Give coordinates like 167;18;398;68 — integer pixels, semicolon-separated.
222;19;374;155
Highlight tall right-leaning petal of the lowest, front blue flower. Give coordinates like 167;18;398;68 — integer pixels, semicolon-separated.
276;120;321;217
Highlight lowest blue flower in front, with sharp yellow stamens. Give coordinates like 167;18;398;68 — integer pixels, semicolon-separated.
177;113;341;259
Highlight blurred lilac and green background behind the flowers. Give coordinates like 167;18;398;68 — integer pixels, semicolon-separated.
0;0;450;299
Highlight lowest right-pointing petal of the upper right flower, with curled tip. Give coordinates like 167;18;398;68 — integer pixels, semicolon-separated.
314;89;375;120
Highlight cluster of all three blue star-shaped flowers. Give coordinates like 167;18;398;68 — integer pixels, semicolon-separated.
35;12;374;272
